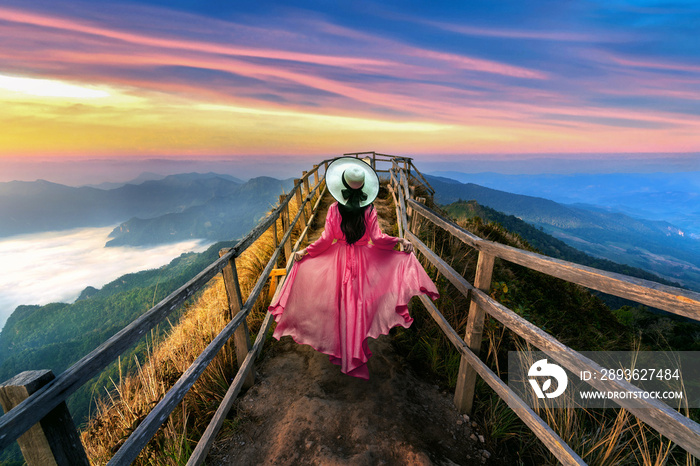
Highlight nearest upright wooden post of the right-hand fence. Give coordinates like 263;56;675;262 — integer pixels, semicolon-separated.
454;251;495;414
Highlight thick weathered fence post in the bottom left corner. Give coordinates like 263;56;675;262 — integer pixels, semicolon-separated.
0;370;90;466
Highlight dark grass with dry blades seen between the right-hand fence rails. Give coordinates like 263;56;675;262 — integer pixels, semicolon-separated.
408;192;695;466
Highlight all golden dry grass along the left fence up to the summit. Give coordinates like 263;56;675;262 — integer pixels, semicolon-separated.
81;187;320;465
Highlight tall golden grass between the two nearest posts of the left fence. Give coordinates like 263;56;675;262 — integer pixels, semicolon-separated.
82;278;236;464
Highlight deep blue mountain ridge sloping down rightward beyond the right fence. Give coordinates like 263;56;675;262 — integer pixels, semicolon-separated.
426;175;700;290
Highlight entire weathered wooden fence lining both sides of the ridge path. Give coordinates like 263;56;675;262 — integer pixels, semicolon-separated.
0;152;700;465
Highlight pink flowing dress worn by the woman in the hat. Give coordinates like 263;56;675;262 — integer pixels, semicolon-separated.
269;202;438;379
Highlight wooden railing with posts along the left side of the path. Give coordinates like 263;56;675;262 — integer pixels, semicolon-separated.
0;160;330;466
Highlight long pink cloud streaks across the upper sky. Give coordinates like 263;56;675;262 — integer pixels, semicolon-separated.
0;9;543;124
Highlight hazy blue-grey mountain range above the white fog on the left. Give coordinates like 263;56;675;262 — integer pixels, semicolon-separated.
0;173;293;246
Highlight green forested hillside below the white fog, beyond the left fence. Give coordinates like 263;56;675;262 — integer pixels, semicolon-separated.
0;242;233;424
